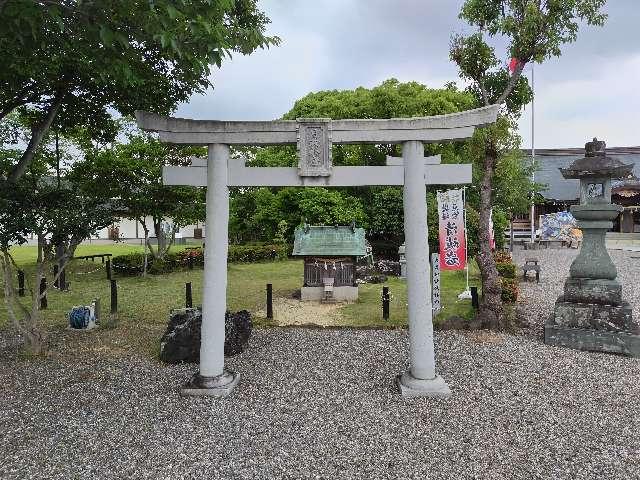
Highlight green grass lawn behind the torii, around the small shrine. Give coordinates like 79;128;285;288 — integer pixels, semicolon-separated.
0;244;479;354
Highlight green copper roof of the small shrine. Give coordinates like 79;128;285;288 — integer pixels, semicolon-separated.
293;226;367;257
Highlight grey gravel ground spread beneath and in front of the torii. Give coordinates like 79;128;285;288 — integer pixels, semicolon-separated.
0;250;640;479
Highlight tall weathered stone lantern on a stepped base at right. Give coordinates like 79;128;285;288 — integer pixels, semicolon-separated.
544;138;640;356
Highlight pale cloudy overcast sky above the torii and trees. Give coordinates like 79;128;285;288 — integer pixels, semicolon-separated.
176;0;640;148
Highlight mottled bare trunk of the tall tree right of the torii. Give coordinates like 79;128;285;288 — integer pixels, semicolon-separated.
476;135;503;330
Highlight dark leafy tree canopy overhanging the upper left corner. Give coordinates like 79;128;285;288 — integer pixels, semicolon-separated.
0;0;279;182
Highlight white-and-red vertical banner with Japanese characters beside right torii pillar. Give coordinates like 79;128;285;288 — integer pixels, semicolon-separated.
438;189;467;270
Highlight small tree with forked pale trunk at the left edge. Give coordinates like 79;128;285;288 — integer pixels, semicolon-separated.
0;150;114;355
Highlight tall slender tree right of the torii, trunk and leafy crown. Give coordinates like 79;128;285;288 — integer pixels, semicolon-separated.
450;0;606;328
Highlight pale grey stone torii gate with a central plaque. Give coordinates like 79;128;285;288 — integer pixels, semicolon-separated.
136;106;498;397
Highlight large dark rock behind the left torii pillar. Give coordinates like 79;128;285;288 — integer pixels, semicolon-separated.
160;308;253;363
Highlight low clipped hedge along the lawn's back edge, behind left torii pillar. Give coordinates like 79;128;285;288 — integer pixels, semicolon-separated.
111;245;289;275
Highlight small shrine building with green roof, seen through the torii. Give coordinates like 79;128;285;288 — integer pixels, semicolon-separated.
292;225;367;302
